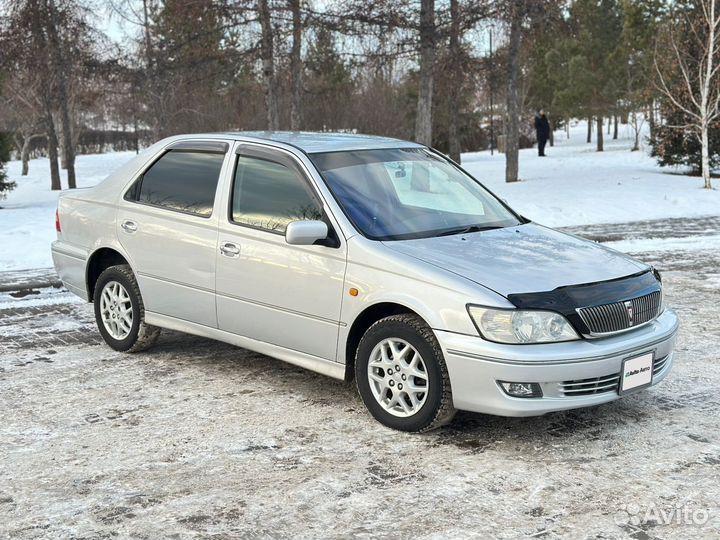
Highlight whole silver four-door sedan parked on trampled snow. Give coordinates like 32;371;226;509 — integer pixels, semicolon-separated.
52;132;678;431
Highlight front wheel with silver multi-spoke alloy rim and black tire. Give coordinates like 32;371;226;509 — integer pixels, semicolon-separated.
355;314;455;432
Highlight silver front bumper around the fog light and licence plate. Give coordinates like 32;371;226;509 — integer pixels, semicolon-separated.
435;310;678;416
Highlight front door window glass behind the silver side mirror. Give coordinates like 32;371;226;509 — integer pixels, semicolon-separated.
231;156;322;233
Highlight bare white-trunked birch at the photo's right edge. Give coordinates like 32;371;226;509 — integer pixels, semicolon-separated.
655;0;720;189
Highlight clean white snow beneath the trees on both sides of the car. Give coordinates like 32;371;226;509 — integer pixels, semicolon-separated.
0;122;720;271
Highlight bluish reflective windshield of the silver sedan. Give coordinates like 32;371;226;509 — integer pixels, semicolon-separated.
310;148;520;240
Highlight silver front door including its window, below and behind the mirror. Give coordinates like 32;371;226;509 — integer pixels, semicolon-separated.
216;145;346;360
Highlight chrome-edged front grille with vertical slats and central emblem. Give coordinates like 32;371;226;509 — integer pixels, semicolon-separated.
577;291;662;335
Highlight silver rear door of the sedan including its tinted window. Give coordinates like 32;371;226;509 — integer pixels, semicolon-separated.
117;141;229;328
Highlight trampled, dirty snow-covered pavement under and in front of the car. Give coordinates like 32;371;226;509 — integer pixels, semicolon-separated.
0;246;720;540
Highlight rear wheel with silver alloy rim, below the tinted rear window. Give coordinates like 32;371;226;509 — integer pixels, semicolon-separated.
93;264;160;353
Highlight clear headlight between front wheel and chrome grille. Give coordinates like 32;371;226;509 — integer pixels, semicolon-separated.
468;306;580;344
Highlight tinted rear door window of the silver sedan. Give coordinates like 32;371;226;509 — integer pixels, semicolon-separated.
127;150;225;217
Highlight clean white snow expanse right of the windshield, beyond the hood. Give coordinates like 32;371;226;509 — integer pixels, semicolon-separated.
462;122;720;227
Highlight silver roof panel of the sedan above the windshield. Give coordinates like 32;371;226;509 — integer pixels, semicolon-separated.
219;131;423;154
